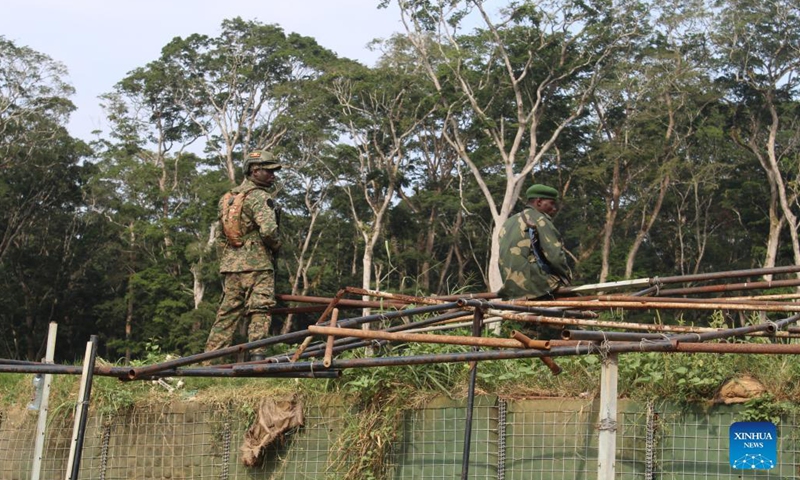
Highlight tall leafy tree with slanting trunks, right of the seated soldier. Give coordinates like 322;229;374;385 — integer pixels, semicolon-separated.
583;1;715;282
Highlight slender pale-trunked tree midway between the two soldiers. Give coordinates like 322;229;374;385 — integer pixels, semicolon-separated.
331;62;435;304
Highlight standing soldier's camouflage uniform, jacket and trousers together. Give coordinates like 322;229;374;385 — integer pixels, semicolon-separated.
206;178;280;354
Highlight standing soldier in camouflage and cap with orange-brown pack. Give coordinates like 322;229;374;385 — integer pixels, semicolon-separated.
206;150;282;361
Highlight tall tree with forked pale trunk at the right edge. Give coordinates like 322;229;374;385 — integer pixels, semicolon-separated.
713;0;800;276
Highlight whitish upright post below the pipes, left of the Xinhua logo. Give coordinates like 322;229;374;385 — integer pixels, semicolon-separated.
597;353;618;480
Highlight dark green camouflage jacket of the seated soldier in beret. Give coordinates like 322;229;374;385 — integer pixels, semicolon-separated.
499;207;572;298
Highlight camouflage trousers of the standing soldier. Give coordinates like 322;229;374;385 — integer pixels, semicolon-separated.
206;270;275;354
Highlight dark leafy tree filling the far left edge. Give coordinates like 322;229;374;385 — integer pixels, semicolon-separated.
0;37;91;360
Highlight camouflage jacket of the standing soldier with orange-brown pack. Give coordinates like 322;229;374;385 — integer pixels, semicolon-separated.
218;178;280;273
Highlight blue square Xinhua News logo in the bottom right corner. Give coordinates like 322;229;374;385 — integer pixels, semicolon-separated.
729;422;778;470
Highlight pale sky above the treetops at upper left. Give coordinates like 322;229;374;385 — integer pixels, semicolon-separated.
0;0;403;141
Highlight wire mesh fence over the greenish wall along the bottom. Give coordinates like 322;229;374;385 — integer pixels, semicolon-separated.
0;397;800;480
